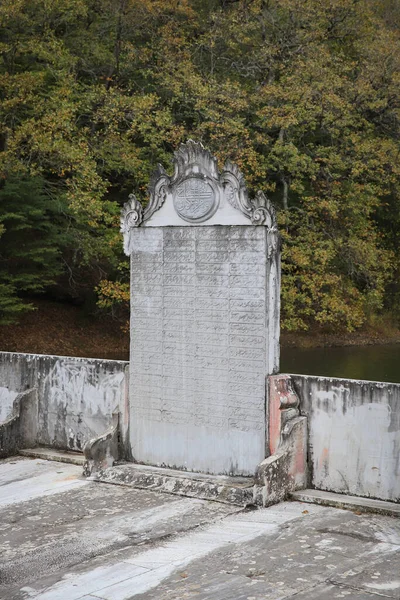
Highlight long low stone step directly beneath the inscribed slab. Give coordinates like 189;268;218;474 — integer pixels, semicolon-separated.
86;463;263;506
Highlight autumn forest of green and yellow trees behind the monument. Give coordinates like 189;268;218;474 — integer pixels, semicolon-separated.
0;0;400;344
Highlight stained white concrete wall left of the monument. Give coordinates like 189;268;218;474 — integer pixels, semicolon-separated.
0;352;128;450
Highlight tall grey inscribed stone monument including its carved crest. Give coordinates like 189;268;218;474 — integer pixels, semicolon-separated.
121;140;280;475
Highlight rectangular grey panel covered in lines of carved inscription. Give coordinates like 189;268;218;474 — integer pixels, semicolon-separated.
130;226;267;475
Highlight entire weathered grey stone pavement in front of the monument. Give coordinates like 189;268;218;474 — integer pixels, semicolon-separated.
0;457;400;600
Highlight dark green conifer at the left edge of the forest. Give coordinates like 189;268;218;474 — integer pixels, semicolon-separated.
0;177;68;324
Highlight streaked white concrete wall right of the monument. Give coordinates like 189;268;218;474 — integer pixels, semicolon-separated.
291;375;400;502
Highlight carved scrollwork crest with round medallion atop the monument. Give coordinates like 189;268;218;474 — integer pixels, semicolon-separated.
121;140;277;236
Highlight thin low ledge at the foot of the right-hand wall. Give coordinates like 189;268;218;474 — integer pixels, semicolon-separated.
290;490;400;517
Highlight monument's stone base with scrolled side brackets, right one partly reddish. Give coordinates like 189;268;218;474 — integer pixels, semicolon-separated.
84;375;308;506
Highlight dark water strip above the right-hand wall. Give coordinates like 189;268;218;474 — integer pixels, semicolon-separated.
280;344;400;383
